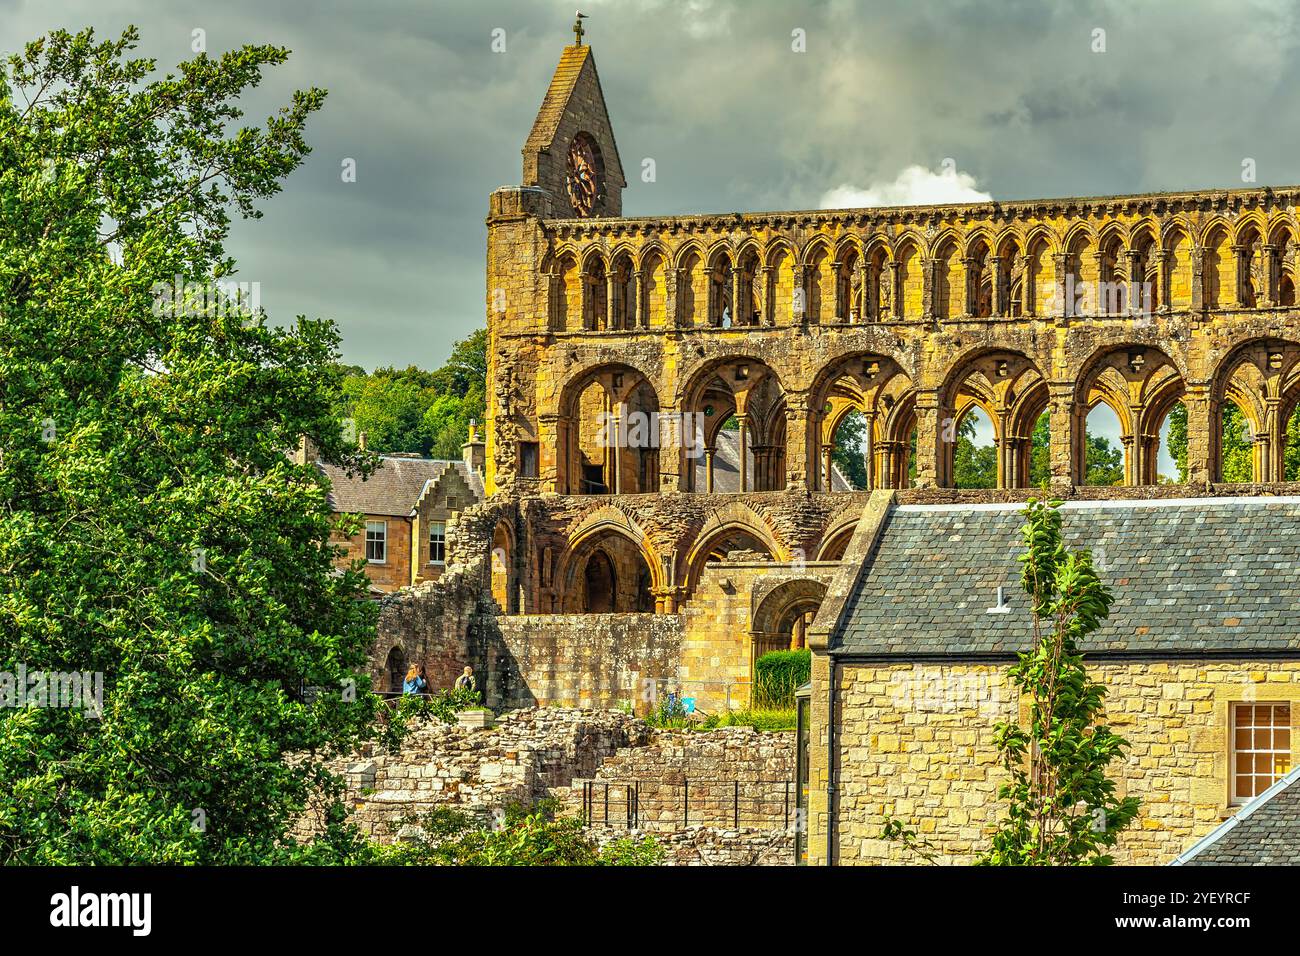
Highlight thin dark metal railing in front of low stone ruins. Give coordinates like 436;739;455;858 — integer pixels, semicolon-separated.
582;777;796;830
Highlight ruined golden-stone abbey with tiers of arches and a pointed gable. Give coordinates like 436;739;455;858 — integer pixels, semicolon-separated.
486;33;1300;624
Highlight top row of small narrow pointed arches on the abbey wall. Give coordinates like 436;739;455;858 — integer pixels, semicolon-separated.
545;221;1297;332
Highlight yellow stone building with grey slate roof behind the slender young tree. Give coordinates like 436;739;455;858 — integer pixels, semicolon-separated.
809;492;1300;864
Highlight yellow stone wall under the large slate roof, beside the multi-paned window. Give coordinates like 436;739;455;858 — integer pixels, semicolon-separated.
809;654;1300;865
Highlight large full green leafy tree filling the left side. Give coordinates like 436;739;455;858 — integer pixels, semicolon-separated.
0;27;377;864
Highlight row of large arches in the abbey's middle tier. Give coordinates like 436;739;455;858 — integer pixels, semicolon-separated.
556;339;1300;494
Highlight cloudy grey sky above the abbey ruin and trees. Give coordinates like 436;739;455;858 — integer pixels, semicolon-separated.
0;0;1300;367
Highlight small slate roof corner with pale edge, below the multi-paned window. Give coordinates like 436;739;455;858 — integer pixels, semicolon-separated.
1173;767;1300;866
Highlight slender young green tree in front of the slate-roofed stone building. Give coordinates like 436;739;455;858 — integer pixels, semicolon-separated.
980;499;1139;866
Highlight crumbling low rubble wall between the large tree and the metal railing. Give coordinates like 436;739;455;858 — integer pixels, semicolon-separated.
298;708;650;843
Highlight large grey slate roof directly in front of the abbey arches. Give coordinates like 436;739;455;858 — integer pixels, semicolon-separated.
831;498;1300;658
